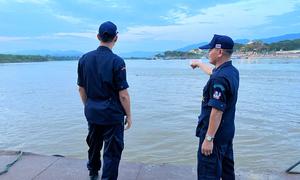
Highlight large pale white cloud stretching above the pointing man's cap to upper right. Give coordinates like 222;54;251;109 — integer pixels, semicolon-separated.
120;0;300;42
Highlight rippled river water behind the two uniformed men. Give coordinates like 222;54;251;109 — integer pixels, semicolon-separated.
0;59;300;171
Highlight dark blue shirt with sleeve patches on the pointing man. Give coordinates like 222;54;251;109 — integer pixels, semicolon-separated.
196;61;239;144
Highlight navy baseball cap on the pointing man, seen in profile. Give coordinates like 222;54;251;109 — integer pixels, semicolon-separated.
199;34;234;49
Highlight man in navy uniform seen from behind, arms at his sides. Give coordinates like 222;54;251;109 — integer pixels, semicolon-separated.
77;21;132;180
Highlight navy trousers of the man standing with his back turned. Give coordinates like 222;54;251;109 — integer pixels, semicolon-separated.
86;123;124;180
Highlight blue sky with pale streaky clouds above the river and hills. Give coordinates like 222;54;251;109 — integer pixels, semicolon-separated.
0;0;300;53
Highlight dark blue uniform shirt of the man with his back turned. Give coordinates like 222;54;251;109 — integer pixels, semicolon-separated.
77;46;129;124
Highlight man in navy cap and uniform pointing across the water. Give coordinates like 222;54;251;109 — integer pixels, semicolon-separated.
191;35;239;180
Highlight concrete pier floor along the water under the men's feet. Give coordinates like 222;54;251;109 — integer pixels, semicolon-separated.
0;151;300;180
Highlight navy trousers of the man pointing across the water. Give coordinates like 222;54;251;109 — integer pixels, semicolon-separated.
197;135;235;180
